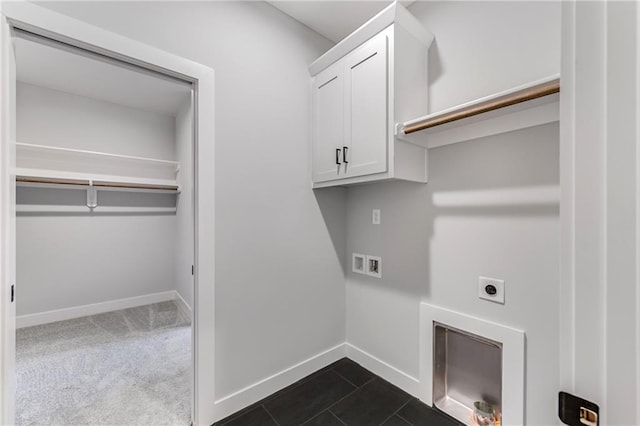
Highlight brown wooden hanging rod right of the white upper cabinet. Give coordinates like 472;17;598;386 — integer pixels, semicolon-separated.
402;78;560;135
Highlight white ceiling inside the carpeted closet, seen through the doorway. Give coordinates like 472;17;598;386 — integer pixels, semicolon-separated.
14;37;191;116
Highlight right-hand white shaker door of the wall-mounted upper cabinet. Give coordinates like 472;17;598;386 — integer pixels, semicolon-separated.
345;33;388;177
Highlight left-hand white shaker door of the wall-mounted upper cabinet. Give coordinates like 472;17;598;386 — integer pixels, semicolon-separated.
312;61;344;182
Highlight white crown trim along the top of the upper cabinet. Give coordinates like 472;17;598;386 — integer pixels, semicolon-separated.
309;1;434;77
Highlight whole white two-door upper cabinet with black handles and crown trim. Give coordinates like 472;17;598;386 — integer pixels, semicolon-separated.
309;3;433;188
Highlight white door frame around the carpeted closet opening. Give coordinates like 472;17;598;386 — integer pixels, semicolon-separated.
0;2;216;424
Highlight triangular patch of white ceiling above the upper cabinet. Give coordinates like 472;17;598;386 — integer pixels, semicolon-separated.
267;0;414;43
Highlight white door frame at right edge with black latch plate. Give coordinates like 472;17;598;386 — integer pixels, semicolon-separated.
559;1;640;424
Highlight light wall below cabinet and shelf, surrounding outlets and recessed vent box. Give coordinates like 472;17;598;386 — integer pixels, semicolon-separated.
347;124;559;424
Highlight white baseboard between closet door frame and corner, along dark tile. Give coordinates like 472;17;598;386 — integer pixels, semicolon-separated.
215;343;345;421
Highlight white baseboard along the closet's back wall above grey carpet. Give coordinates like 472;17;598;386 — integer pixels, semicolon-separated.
16;290;178;328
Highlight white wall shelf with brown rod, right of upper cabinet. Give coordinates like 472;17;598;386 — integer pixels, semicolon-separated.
396;75;560;148
